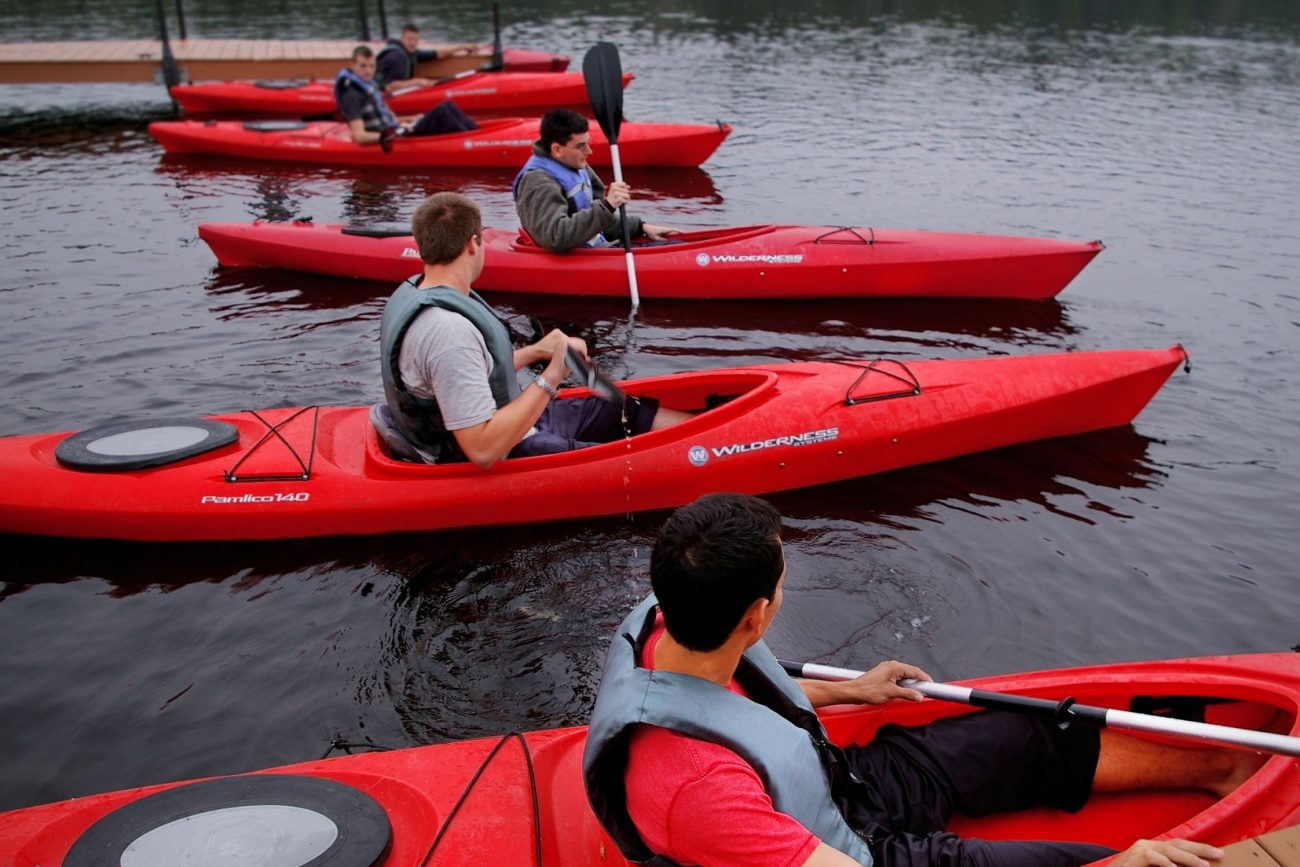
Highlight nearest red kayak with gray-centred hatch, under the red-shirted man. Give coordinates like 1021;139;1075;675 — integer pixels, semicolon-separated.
0;653;1300;867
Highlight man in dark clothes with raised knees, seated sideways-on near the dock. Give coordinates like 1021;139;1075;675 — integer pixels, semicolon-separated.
334;45;478;152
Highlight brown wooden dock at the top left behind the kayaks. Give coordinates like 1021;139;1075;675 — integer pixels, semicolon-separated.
0;39;491;84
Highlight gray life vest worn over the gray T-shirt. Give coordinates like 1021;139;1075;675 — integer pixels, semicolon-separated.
380;274;520;463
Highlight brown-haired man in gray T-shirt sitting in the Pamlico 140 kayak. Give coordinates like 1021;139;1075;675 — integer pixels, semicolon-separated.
380;192;689;468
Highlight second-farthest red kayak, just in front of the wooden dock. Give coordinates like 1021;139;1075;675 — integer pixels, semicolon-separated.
172;70;632;117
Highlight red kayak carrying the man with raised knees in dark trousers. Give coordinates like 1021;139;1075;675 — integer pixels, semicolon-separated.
150;117;732;168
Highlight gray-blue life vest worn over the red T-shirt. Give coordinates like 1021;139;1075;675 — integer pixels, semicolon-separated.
582;594;871;867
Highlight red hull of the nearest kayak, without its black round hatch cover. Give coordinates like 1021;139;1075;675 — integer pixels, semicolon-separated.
0;653;1300;867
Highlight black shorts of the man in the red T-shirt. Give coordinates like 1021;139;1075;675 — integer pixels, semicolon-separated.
846;711;1114;867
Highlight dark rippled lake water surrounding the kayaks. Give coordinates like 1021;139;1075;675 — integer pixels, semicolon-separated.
0;0;1300;809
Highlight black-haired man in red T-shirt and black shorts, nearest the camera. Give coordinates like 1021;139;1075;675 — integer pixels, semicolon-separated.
582;494;1262;867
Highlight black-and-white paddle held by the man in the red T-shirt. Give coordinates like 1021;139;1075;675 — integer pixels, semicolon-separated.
781;660;1300;757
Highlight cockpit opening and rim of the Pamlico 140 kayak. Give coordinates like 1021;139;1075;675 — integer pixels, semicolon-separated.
365;369;780;476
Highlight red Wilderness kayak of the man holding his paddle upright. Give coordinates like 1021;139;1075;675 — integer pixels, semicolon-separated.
199;220;1104;299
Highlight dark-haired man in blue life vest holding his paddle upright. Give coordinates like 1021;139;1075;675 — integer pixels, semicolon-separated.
514;108;680;253
